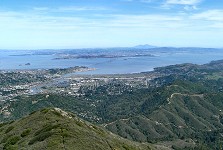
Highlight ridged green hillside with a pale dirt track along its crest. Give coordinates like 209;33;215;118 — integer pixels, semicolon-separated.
106;80;223;148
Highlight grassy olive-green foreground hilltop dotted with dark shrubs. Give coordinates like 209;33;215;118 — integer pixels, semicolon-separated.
0;108;153;150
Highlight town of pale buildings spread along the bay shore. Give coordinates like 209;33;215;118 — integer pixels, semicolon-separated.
0;67;160;118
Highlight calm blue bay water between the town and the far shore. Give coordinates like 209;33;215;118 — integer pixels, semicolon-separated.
0;50;223;74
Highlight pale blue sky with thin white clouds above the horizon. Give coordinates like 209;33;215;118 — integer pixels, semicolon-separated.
0;0;223;49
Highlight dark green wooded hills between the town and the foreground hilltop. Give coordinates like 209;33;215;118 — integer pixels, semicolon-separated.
1;61;223;149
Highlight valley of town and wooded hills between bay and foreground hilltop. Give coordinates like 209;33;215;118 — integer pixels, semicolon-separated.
0;61;223;149
